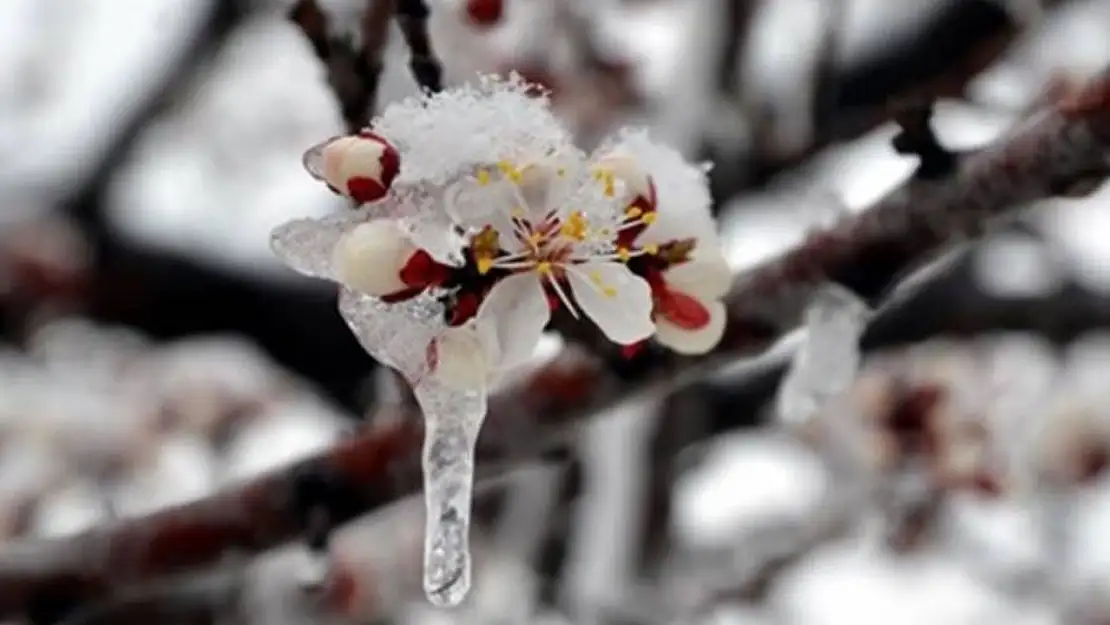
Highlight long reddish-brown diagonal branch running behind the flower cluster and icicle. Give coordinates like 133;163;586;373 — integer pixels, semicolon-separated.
0;66;1110;617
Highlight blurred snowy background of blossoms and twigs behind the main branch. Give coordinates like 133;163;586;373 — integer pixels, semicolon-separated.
0;0;1110;625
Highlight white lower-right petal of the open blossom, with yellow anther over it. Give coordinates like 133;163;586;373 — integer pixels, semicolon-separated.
567;261;655;345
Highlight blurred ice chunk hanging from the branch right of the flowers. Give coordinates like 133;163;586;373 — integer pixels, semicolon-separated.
778;284;870;424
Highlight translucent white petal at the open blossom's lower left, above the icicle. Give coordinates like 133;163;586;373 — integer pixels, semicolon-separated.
475;272;551;369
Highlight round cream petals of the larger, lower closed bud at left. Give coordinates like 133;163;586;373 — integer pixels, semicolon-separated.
332;219;416;296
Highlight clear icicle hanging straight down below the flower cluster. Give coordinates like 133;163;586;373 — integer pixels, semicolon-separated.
415;380;486;606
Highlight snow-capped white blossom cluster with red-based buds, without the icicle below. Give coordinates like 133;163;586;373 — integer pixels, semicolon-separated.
273;78;730;389
